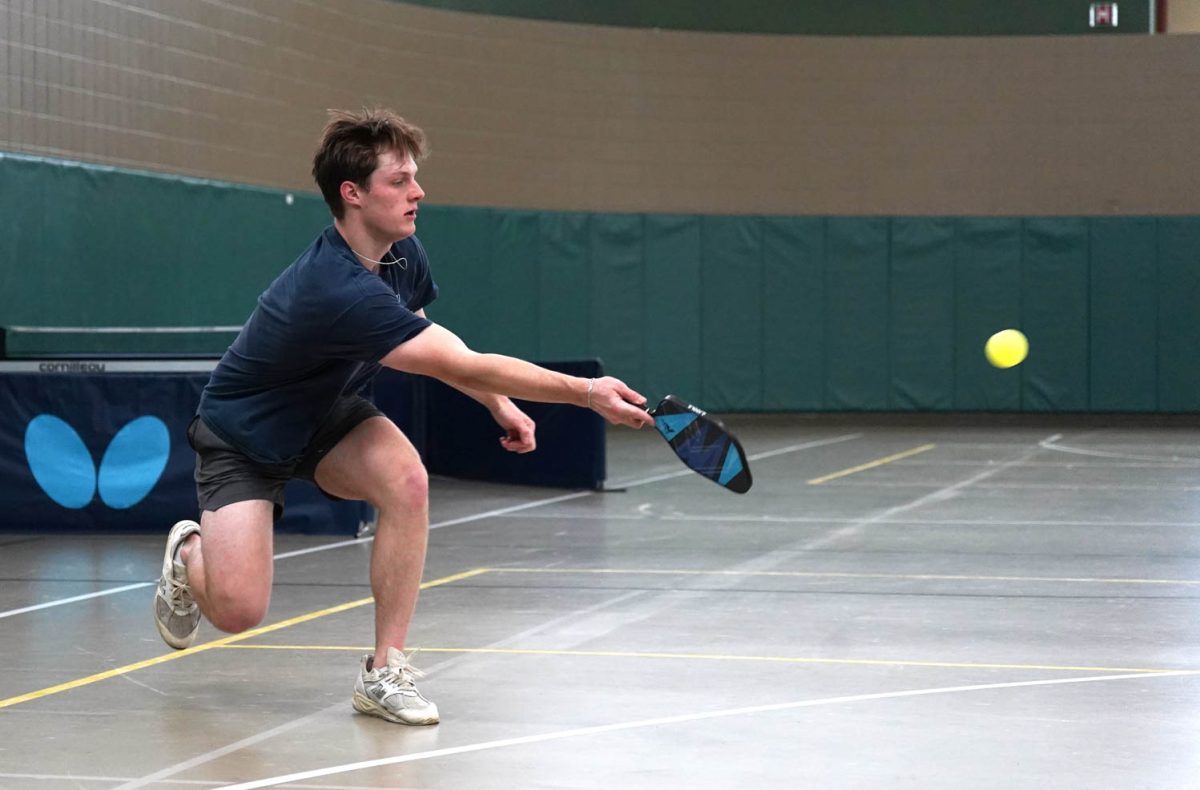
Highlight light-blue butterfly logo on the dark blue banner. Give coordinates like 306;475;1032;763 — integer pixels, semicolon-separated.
25;414;170;510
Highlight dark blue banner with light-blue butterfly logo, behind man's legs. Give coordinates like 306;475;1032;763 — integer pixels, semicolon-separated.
0;359;372;534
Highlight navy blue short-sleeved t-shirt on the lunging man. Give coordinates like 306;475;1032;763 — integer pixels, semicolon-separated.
199;226;438;463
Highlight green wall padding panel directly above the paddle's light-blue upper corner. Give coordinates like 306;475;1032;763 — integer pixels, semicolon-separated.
648;214;704;403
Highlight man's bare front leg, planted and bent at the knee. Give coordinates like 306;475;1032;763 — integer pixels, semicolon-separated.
316;417;430;666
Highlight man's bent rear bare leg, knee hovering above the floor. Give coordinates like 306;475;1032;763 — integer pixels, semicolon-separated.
179;499;274;634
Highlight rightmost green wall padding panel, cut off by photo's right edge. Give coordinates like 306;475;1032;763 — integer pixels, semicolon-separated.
1158;217;1200;412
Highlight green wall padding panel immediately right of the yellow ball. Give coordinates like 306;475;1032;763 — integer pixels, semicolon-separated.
1020;217;1088;412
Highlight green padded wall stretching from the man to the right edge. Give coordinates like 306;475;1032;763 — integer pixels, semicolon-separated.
421;208;1200;412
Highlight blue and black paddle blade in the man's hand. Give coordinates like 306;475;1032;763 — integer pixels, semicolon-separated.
650;395;754;493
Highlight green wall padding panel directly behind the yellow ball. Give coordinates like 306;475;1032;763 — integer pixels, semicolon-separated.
954;217;1021;412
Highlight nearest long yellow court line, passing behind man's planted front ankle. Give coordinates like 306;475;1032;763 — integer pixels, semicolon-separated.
221;645;1200;675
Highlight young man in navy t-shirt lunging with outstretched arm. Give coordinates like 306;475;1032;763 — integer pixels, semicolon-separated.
155;110;653;724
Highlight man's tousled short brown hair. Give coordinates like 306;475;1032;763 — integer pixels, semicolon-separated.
312;109;428;220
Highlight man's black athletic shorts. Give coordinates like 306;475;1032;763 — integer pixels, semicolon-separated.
187;395;383;519
